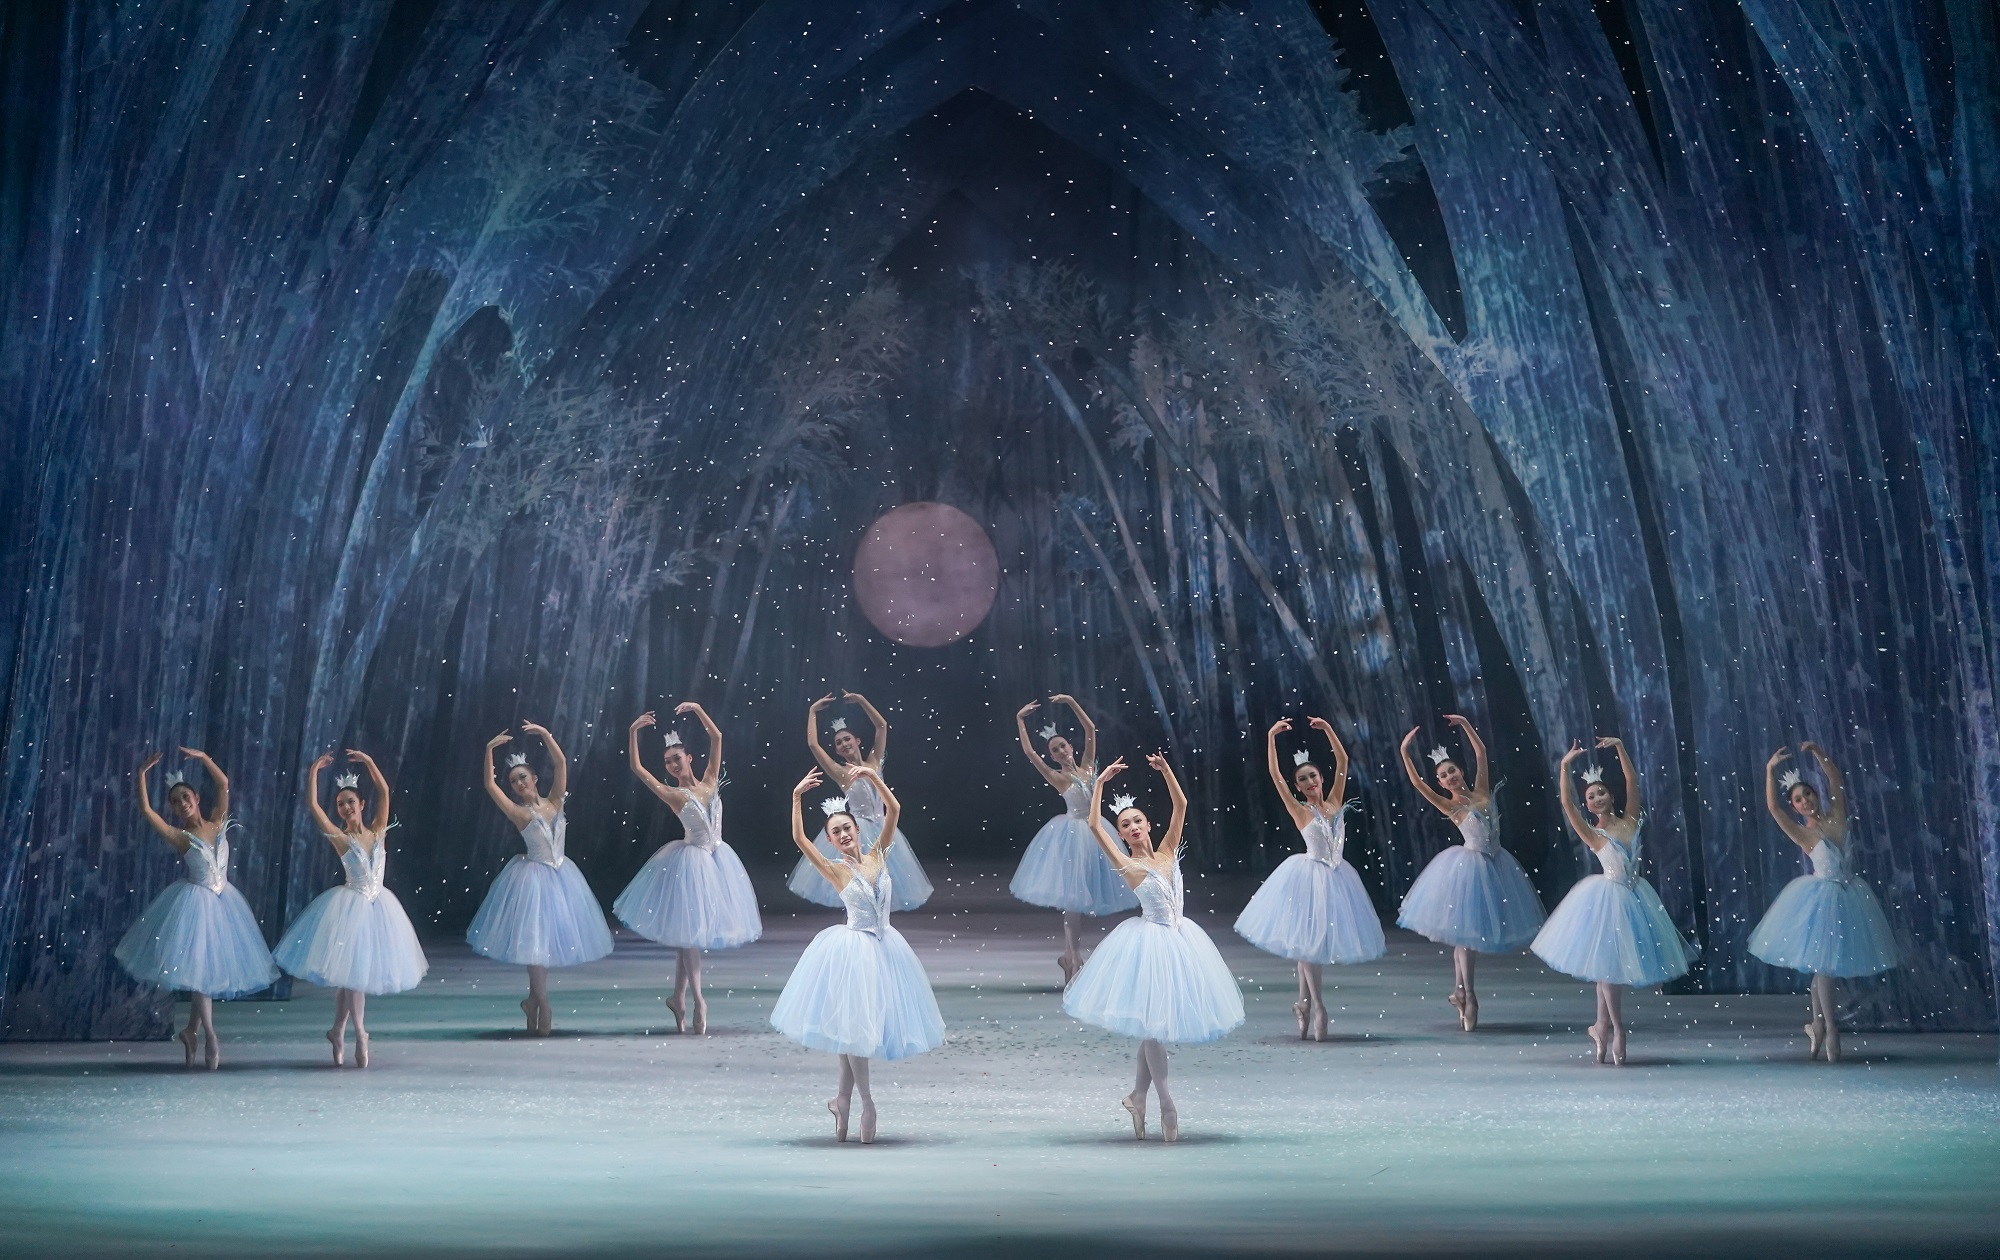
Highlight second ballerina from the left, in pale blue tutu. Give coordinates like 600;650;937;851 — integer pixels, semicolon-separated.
274;748;430;1068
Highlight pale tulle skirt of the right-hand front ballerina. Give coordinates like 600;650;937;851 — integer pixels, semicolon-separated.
1062;918;1244;1044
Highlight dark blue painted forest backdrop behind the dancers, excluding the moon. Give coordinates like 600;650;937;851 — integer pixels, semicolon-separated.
0;0;2000;1038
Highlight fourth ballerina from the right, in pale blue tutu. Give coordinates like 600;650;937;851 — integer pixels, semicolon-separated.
1236;718;1386;1042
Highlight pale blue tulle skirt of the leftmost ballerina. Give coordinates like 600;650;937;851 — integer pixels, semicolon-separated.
112;880;278;998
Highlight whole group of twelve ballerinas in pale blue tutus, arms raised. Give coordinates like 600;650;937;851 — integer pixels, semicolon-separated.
116;692;1898;1142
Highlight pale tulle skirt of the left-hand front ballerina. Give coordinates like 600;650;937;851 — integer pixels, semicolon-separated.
770;924;944;1060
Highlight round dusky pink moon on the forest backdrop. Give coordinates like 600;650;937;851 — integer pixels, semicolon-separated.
854;502;1000;648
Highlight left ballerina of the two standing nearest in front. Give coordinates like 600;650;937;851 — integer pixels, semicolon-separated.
770;764;944;1142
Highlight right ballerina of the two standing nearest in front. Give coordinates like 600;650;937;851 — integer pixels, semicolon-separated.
1062;752;1244;1142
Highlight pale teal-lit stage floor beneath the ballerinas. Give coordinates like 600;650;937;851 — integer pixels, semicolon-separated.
0;872;2000;1256
